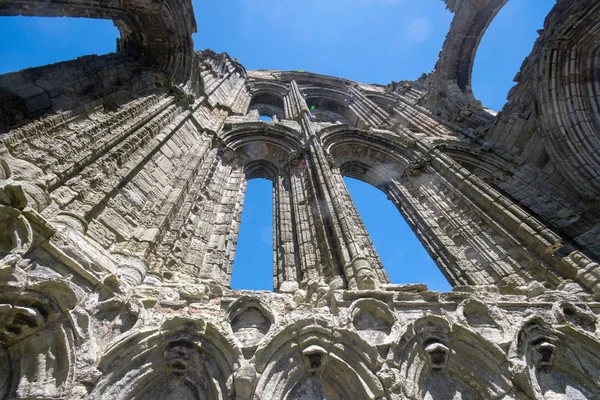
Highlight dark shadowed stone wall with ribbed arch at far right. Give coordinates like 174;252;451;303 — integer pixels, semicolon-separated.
481;1;600;261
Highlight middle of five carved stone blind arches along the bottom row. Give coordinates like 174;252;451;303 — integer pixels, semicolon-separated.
252;318;385;400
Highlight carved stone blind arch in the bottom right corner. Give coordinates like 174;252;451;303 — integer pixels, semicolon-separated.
510;318;600;400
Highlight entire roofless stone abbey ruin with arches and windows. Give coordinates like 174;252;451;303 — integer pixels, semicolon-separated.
0;0;600;400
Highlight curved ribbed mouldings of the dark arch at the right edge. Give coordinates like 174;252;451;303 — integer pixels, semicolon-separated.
535;2;600;199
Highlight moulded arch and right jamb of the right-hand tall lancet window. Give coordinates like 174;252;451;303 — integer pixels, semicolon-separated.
320;127;558;291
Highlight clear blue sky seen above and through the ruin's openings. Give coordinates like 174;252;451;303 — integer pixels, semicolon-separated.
0;0;556;290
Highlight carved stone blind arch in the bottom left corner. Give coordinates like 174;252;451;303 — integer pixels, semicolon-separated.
0;277;77;399
